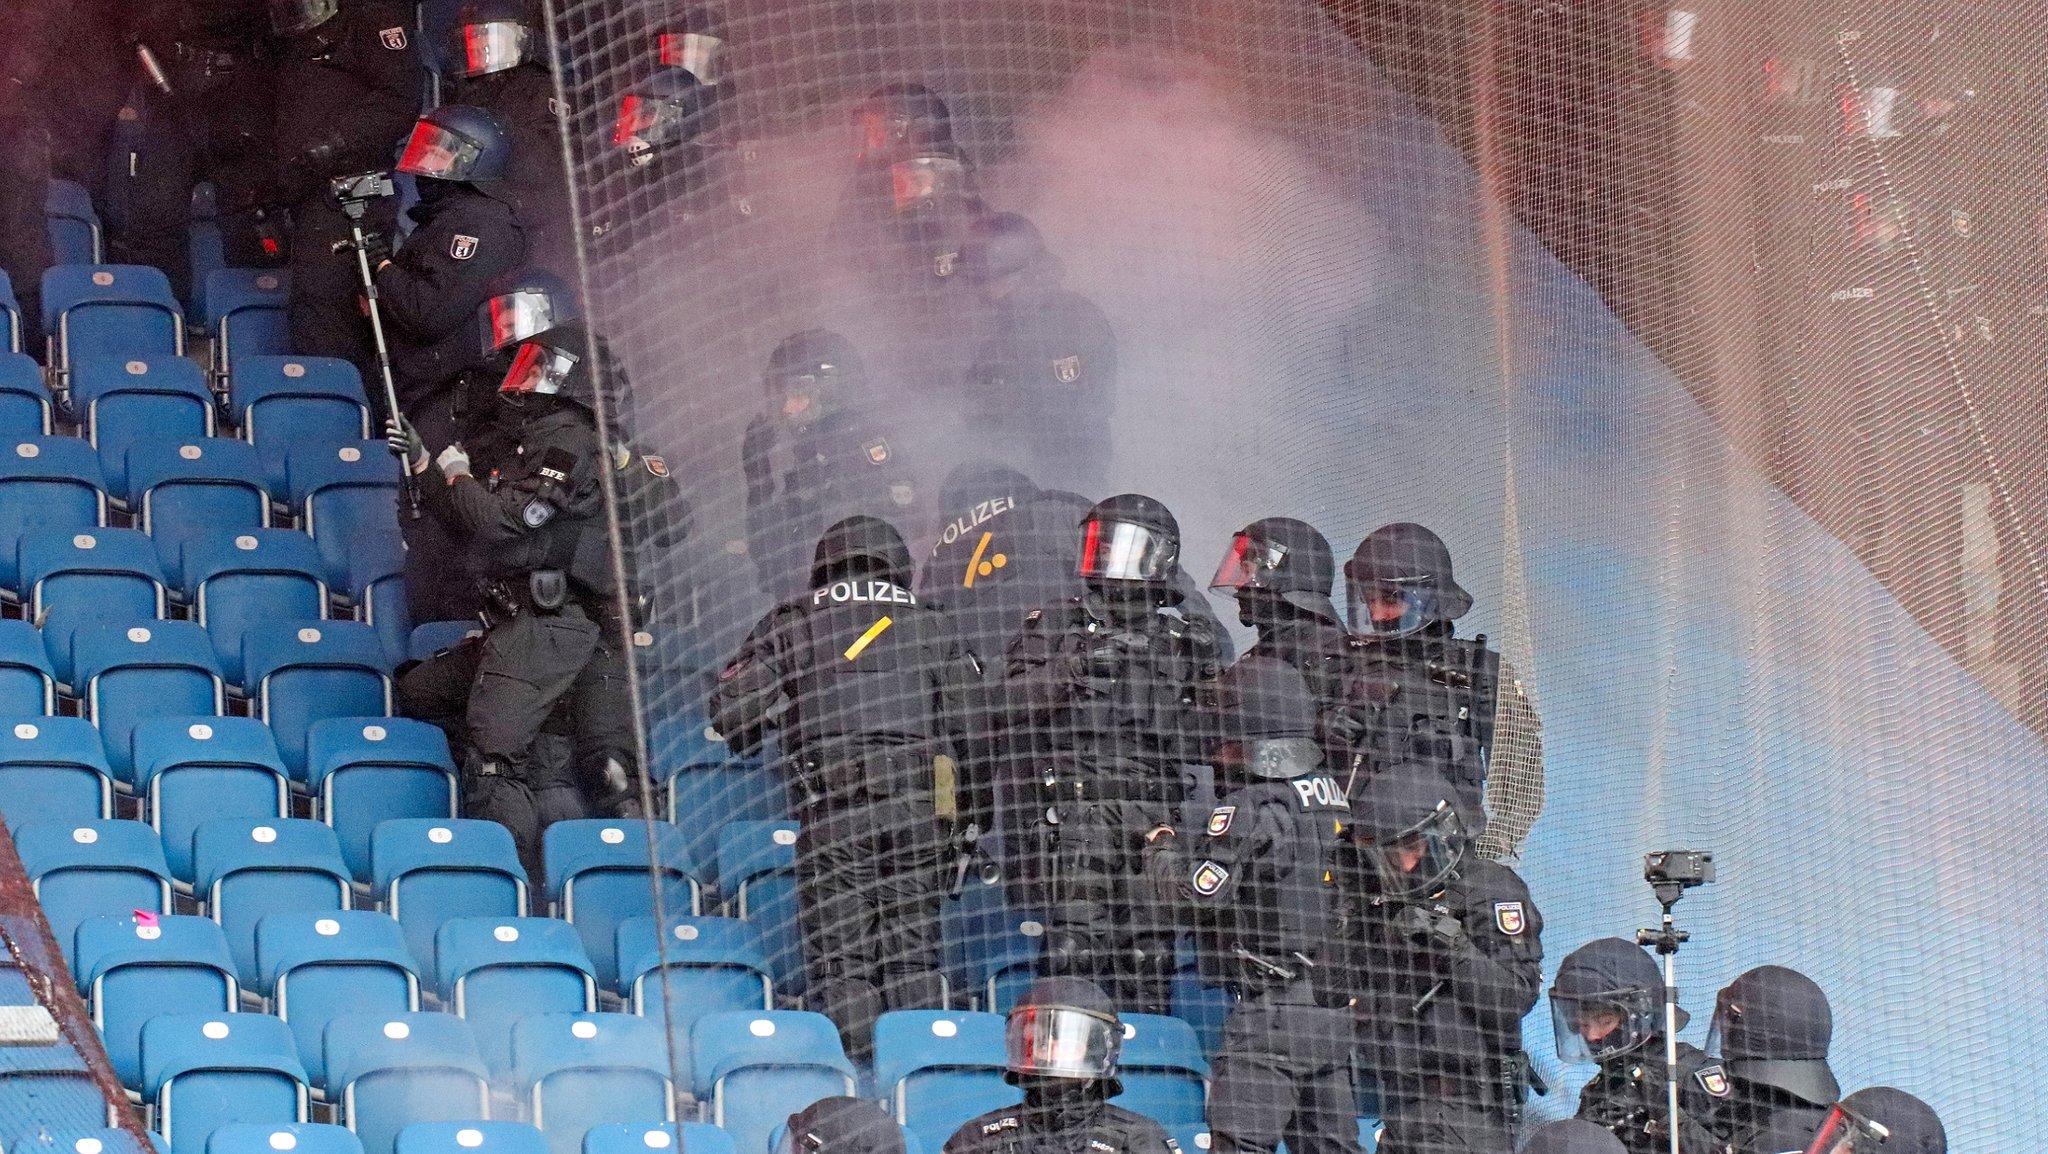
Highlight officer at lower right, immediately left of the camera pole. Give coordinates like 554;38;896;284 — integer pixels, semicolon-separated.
1550;937;1714;1154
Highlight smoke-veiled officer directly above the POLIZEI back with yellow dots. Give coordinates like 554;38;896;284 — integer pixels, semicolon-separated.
958;213;1116;490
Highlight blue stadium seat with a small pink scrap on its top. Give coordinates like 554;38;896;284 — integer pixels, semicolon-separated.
74;914;240;1093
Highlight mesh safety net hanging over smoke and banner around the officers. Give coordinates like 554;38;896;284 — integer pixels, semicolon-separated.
536;0;2048;1148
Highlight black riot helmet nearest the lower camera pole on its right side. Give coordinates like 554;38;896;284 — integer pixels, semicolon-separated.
1706;965;1841;1105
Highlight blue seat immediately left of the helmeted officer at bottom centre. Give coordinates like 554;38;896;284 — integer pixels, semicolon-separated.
874;1011;1024;1150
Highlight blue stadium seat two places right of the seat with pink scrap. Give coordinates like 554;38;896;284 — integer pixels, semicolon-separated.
434;918;598;1074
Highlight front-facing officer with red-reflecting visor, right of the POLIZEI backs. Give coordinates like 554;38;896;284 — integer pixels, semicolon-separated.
1001;494;1223;1013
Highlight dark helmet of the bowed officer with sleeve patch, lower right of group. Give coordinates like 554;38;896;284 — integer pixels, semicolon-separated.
1348;765;1470;902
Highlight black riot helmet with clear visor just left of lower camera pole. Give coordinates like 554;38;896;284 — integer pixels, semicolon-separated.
1550;937;1686;1066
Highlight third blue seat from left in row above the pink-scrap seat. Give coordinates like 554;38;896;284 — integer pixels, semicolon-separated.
371;818;526;978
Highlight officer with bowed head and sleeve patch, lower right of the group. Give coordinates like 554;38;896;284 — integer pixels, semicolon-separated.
1348;765;1542;1154
